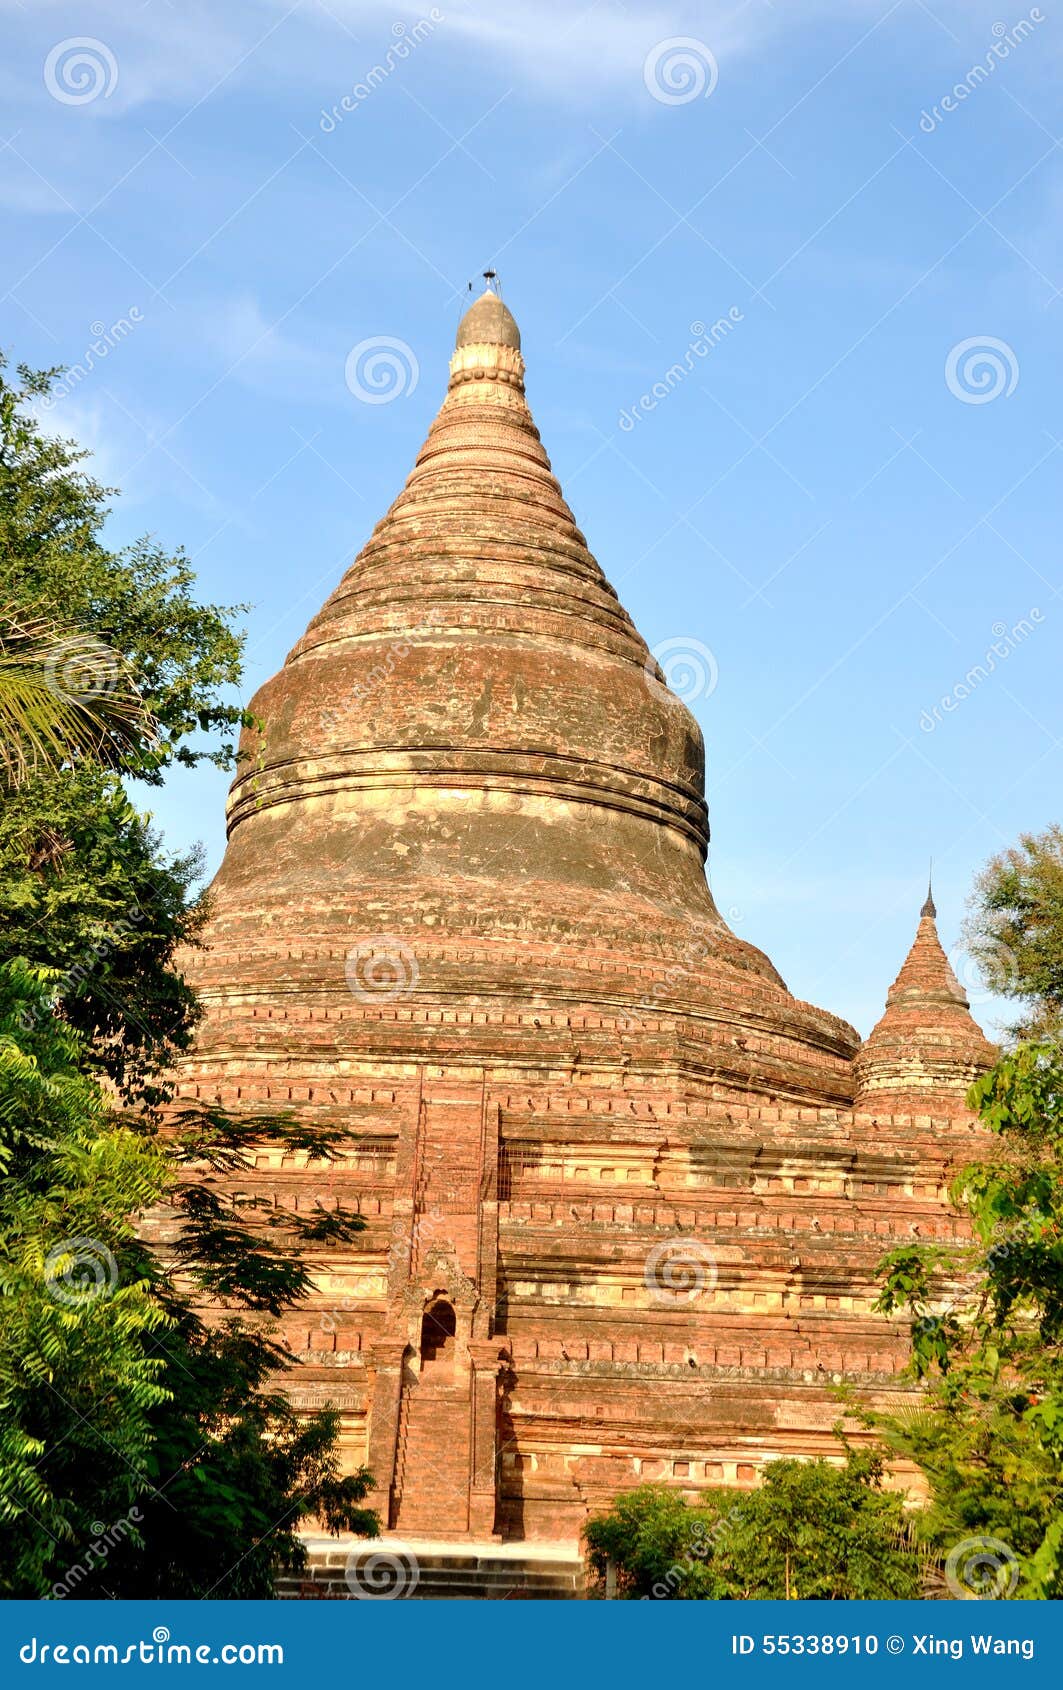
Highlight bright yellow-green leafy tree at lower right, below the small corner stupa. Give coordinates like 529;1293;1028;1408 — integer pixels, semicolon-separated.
870;1043;1063;1597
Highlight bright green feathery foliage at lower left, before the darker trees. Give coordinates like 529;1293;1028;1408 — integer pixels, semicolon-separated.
0;963;167;1595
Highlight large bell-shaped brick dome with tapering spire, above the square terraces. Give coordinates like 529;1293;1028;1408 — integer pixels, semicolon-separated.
182;289;857;1099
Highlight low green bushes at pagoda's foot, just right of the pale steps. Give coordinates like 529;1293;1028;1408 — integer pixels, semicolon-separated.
585;1450;923;1600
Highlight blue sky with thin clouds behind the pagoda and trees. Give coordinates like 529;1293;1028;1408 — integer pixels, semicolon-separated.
0;0;1063;1033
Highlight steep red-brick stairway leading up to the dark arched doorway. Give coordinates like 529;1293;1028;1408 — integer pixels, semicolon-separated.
392;1364;472;1538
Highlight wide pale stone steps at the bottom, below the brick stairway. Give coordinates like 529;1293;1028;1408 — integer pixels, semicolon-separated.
277;1533;586;1602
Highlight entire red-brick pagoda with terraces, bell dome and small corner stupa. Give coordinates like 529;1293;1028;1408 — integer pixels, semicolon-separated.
179;289;994;1540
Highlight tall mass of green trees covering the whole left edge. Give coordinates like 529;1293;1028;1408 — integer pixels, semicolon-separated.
0;365;379;1597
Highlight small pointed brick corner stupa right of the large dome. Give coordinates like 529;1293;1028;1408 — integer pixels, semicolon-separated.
855;887;995;1114
